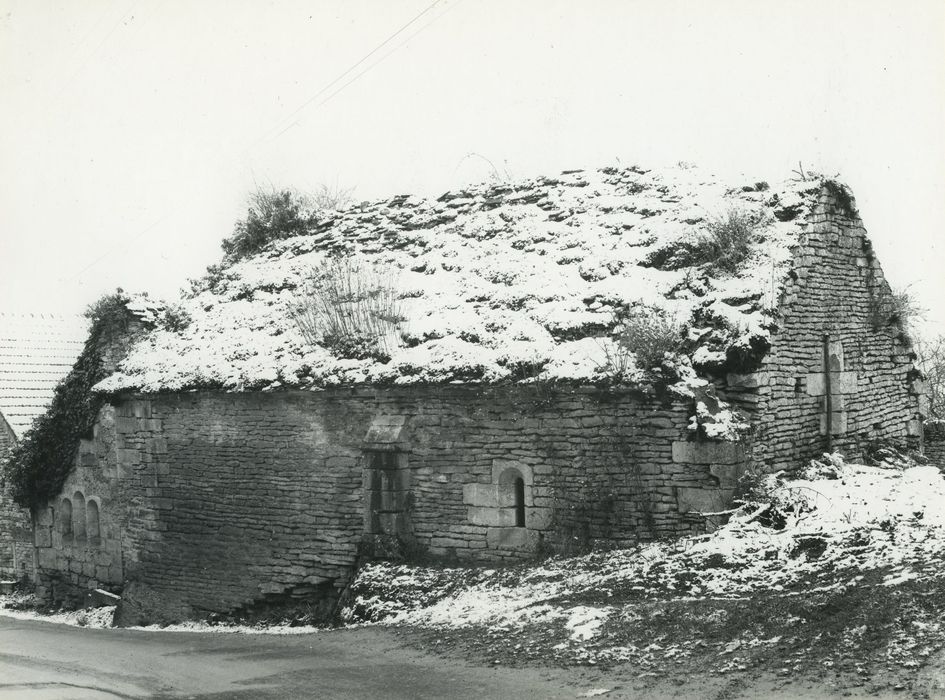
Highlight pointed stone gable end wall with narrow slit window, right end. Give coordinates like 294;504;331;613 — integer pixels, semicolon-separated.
724;189;922;471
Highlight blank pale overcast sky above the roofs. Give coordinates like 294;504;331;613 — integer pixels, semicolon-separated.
0;0;945;334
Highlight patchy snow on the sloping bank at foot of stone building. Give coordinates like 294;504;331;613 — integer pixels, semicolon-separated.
343;448;945;660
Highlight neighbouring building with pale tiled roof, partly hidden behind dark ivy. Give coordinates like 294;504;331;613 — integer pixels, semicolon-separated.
0;312;86;580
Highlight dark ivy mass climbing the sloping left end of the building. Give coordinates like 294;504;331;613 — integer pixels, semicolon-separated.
3;289;133;509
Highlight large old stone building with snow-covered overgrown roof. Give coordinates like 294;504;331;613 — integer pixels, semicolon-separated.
18;167;924;622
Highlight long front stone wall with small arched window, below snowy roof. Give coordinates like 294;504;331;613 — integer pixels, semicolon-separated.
31;386;742;622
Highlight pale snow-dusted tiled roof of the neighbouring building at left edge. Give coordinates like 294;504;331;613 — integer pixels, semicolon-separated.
0;312;88;438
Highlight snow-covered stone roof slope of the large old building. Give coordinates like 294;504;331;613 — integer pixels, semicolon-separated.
98;166;820;391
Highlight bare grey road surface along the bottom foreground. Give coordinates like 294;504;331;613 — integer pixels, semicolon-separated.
0;617;945;700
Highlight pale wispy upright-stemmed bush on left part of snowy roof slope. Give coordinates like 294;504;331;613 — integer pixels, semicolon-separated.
289;256;404;362
